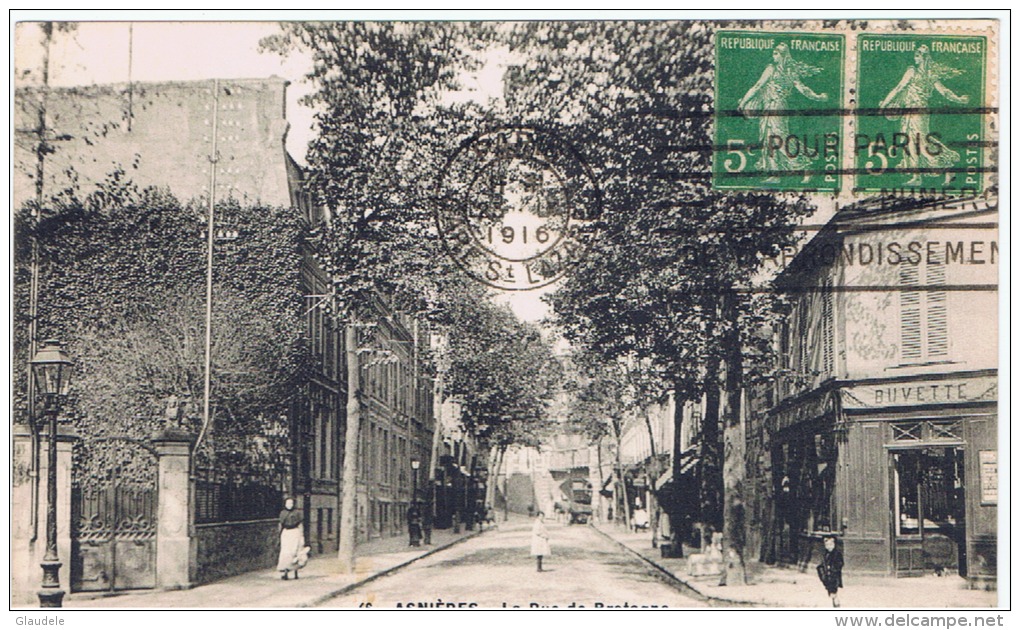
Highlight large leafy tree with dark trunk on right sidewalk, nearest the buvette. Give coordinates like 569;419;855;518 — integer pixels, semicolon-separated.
508;21;810;581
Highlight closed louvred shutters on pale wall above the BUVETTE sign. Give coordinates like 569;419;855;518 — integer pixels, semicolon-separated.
899;253;949;361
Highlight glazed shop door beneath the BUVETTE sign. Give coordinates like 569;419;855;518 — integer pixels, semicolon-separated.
890;447;967;577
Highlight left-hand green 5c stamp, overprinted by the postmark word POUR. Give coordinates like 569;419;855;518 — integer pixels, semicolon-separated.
712;31;845;192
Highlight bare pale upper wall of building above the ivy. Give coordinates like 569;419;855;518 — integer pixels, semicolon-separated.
13;77;295;207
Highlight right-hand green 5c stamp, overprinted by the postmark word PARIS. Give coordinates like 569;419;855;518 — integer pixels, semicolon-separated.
854;34;986;194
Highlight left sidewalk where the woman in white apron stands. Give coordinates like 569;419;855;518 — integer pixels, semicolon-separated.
55;528;482;609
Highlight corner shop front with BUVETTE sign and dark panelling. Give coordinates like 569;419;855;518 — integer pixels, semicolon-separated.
770;370;998;587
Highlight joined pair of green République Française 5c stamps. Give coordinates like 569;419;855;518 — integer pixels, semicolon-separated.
712;30;993;195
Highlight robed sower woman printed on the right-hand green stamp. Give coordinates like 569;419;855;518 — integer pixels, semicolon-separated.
878;46;970;186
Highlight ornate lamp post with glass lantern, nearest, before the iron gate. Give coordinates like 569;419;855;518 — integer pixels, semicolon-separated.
31;339;71;609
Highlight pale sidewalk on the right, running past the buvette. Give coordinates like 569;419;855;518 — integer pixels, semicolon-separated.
596;524;999;609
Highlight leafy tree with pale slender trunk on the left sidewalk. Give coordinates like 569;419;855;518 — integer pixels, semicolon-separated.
262;22;526;572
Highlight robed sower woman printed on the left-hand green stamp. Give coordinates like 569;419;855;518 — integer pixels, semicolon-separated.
736;44;828;183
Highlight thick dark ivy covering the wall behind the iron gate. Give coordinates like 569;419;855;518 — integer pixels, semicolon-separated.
12;172;308;483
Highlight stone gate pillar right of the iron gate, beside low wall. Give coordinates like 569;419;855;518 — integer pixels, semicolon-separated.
153;432;197;588
